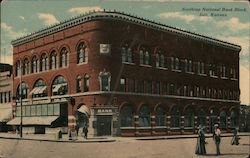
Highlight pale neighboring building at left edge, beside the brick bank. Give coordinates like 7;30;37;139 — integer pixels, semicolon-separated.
0;63;13;132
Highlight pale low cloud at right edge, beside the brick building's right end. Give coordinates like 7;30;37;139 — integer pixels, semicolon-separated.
240;65;250;105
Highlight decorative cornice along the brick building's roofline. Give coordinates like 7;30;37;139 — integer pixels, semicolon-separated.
11;10;241;52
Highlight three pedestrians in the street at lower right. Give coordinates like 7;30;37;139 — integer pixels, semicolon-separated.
195;124;240;155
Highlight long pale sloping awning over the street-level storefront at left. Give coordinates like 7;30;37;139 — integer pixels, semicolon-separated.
7;116;59;125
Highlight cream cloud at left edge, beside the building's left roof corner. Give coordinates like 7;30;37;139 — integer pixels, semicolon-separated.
1;22;27;39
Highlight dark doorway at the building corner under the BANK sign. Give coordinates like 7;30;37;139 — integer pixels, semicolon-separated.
97;115;112;136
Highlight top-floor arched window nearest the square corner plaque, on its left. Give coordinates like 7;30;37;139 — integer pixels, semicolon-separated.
77;42;88;64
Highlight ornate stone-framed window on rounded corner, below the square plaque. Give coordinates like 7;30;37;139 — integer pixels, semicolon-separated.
99;72;111;91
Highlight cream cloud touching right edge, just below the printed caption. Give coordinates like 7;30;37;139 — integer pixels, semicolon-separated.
216;17;250;32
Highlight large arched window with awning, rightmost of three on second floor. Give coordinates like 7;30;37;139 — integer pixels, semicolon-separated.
52;76;68;95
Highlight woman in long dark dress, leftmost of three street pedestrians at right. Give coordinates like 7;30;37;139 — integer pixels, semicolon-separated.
195;125;206;155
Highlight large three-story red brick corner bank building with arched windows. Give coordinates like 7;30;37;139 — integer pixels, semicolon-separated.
9;11;241;136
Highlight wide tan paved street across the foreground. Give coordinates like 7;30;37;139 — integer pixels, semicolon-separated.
0;136;250;158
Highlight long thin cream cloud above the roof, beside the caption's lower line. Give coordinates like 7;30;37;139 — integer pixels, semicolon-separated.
157;12;212;23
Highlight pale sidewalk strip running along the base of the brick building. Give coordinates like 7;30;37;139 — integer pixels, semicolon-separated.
0;133;250;143
